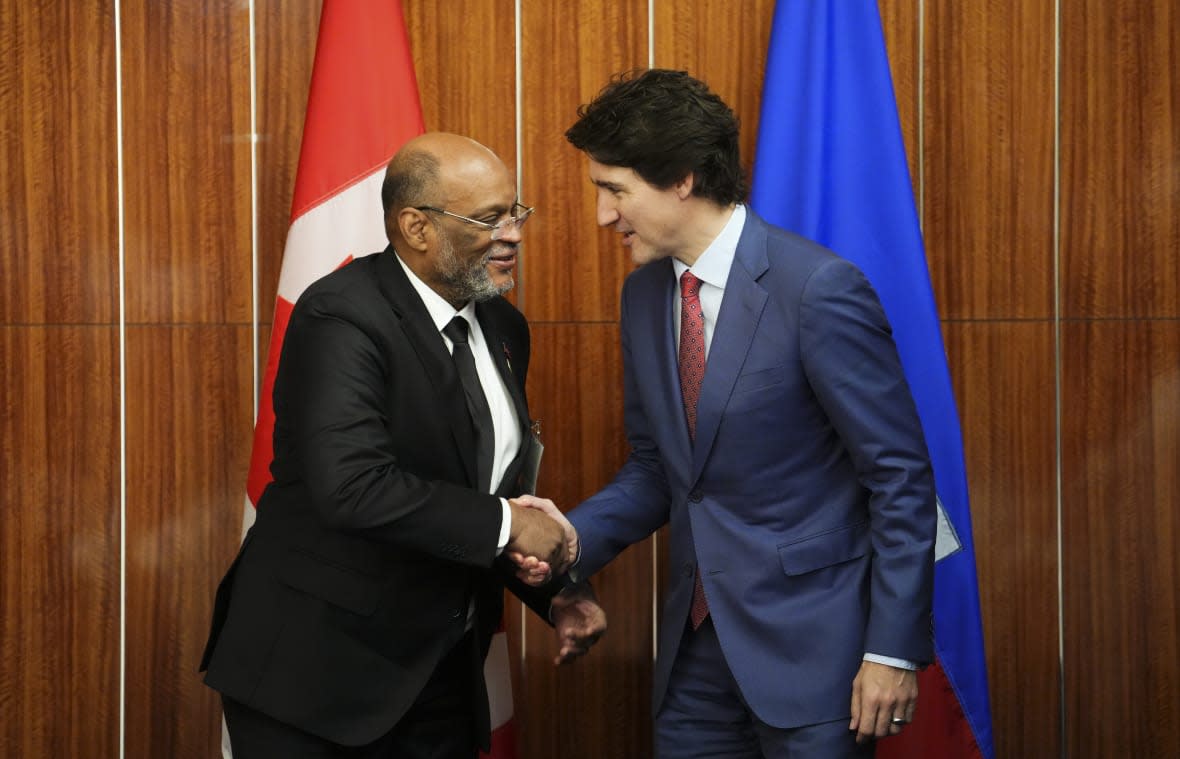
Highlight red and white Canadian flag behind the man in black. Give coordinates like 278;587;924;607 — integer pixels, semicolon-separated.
232;0;516;759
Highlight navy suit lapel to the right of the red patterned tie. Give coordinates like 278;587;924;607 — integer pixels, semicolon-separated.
691;211;768;479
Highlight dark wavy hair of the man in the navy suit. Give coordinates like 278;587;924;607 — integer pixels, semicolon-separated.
565;68;748;205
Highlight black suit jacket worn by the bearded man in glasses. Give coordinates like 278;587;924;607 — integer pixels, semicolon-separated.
202;248;551;745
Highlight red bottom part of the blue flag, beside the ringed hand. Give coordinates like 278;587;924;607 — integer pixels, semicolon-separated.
876;661;983;759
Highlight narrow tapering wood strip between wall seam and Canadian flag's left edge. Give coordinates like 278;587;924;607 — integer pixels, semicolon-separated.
255;0;320;332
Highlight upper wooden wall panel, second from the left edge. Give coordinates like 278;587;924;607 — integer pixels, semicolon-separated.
122;0;251;323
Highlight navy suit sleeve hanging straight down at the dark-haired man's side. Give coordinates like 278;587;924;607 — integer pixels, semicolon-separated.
800;259;937;663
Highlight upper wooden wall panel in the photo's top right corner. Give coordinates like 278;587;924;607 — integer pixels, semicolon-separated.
1061;0;1180;318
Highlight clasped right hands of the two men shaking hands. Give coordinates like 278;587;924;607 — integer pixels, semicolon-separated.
504;496;578;587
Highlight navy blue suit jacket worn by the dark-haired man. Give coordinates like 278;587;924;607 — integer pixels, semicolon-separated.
569;211;936;727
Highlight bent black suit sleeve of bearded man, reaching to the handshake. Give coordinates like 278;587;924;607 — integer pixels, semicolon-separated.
274;294;502;567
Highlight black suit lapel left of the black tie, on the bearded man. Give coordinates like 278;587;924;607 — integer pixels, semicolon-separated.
376;247;477;485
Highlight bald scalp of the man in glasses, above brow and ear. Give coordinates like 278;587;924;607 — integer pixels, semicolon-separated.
381;132;507;242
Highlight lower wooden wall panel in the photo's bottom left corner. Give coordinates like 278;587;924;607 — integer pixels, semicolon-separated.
0;325;119;759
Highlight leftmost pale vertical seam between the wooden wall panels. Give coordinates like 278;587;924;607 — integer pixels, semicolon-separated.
113;0;127;759
